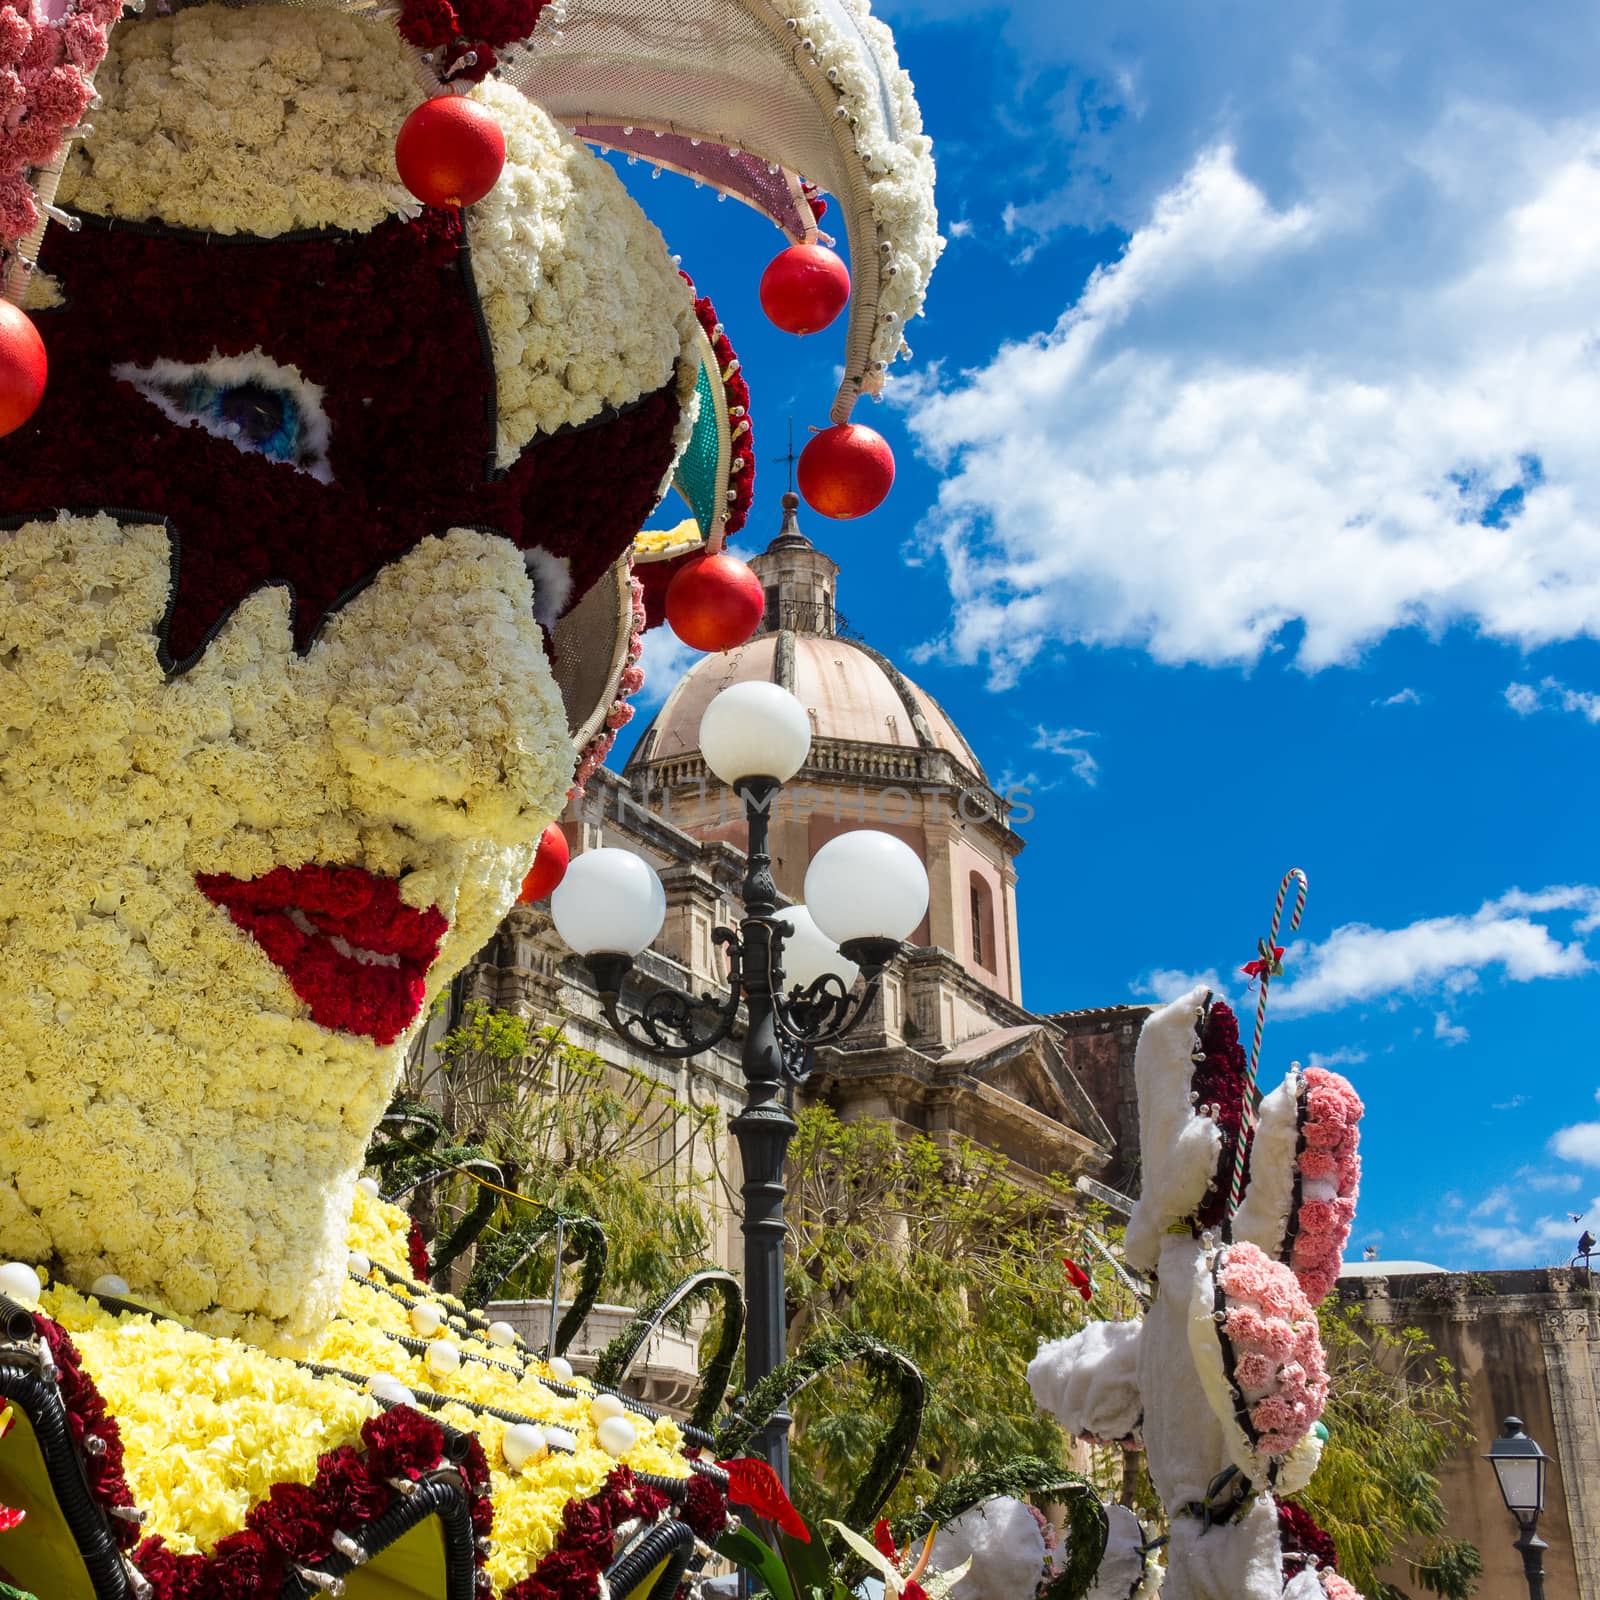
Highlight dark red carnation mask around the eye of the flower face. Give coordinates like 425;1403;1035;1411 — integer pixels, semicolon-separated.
0;211;678;672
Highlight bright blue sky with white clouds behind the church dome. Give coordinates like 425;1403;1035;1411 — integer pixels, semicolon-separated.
601;0;1600;1267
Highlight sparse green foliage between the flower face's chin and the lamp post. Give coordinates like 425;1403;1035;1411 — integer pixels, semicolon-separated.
392;1002;715;1302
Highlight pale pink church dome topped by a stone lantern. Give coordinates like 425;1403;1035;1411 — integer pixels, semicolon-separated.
627;494;989;784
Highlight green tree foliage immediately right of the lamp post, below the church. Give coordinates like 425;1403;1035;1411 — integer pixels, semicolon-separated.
787;1107;1125;1520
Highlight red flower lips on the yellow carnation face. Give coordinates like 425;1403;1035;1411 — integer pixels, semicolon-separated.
195;866;450;1045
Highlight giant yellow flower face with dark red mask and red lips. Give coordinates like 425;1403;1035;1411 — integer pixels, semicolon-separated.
0;6;693;1344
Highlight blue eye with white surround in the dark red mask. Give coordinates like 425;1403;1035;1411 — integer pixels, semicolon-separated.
112;346;333;483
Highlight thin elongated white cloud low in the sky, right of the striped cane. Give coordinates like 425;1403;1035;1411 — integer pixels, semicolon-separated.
1272;885;1600;1011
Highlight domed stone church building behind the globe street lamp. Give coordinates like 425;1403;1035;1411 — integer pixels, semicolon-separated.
467;494;1149;1264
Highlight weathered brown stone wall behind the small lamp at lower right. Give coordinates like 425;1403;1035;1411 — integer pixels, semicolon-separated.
1341;1267;1600;1600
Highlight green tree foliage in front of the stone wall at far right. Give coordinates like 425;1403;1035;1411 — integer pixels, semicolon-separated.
1294;1301;1482;1600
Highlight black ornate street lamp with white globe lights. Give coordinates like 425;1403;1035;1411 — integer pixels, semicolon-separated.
550;683;928;1485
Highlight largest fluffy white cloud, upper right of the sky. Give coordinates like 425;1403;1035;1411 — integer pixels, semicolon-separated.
907;120;1600;688
